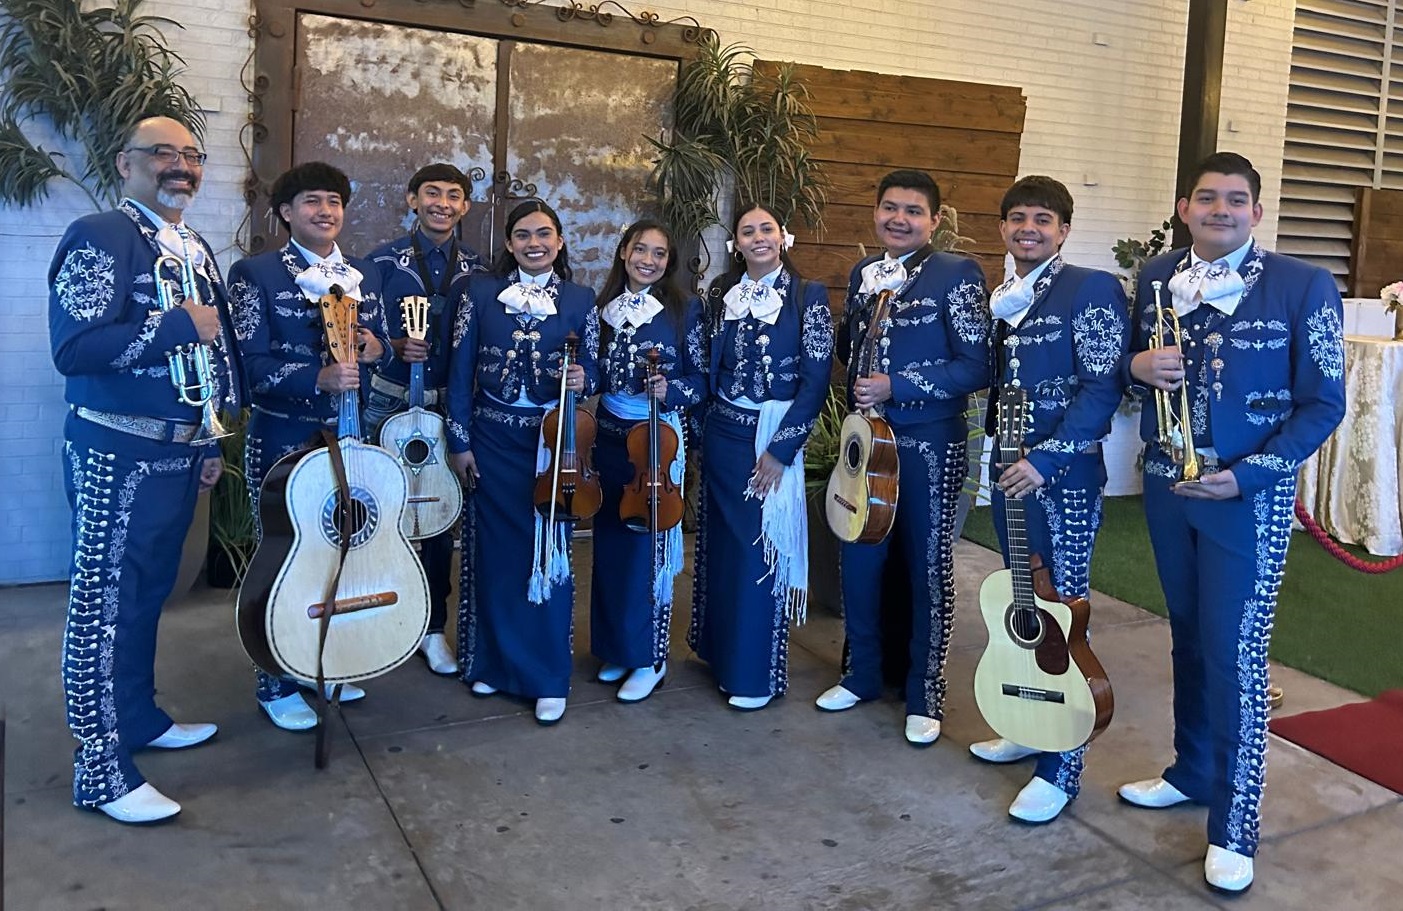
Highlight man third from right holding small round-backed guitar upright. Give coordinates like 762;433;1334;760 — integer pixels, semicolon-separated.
817;171;989;747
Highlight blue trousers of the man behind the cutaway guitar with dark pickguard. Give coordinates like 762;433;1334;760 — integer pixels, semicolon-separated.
989;449;1106;797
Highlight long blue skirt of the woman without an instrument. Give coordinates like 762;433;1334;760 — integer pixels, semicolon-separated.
687;401;788;696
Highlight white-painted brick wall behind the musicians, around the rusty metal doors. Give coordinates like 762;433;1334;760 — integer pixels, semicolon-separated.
0;0;1295;584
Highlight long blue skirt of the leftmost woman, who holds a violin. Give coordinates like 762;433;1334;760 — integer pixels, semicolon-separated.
457;399;575;699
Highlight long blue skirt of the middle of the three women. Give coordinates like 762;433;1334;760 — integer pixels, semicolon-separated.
589;404;672;668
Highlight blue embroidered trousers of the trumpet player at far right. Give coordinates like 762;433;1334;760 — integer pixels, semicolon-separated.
1145;463;1296;856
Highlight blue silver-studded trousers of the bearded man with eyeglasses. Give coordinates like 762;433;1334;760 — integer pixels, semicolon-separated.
63;413;203;807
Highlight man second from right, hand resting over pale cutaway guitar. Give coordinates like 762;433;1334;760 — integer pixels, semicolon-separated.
969;175;1129;824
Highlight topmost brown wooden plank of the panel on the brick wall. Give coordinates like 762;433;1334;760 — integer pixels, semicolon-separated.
774;66;1027;136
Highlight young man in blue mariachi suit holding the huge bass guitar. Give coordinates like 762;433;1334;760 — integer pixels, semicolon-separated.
229;161;391;730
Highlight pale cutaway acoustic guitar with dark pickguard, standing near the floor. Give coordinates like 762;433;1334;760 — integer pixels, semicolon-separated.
974;386;1115;752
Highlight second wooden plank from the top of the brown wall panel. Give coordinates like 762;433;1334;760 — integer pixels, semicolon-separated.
810;117;1019;182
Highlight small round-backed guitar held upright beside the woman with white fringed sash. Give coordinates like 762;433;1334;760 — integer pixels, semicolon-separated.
824;291;901;545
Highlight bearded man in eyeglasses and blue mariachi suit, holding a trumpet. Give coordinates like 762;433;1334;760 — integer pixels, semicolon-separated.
49;117;243;824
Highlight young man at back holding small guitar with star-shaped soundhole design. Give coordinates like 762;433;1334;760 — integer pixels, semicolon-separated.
365;161;487;674
